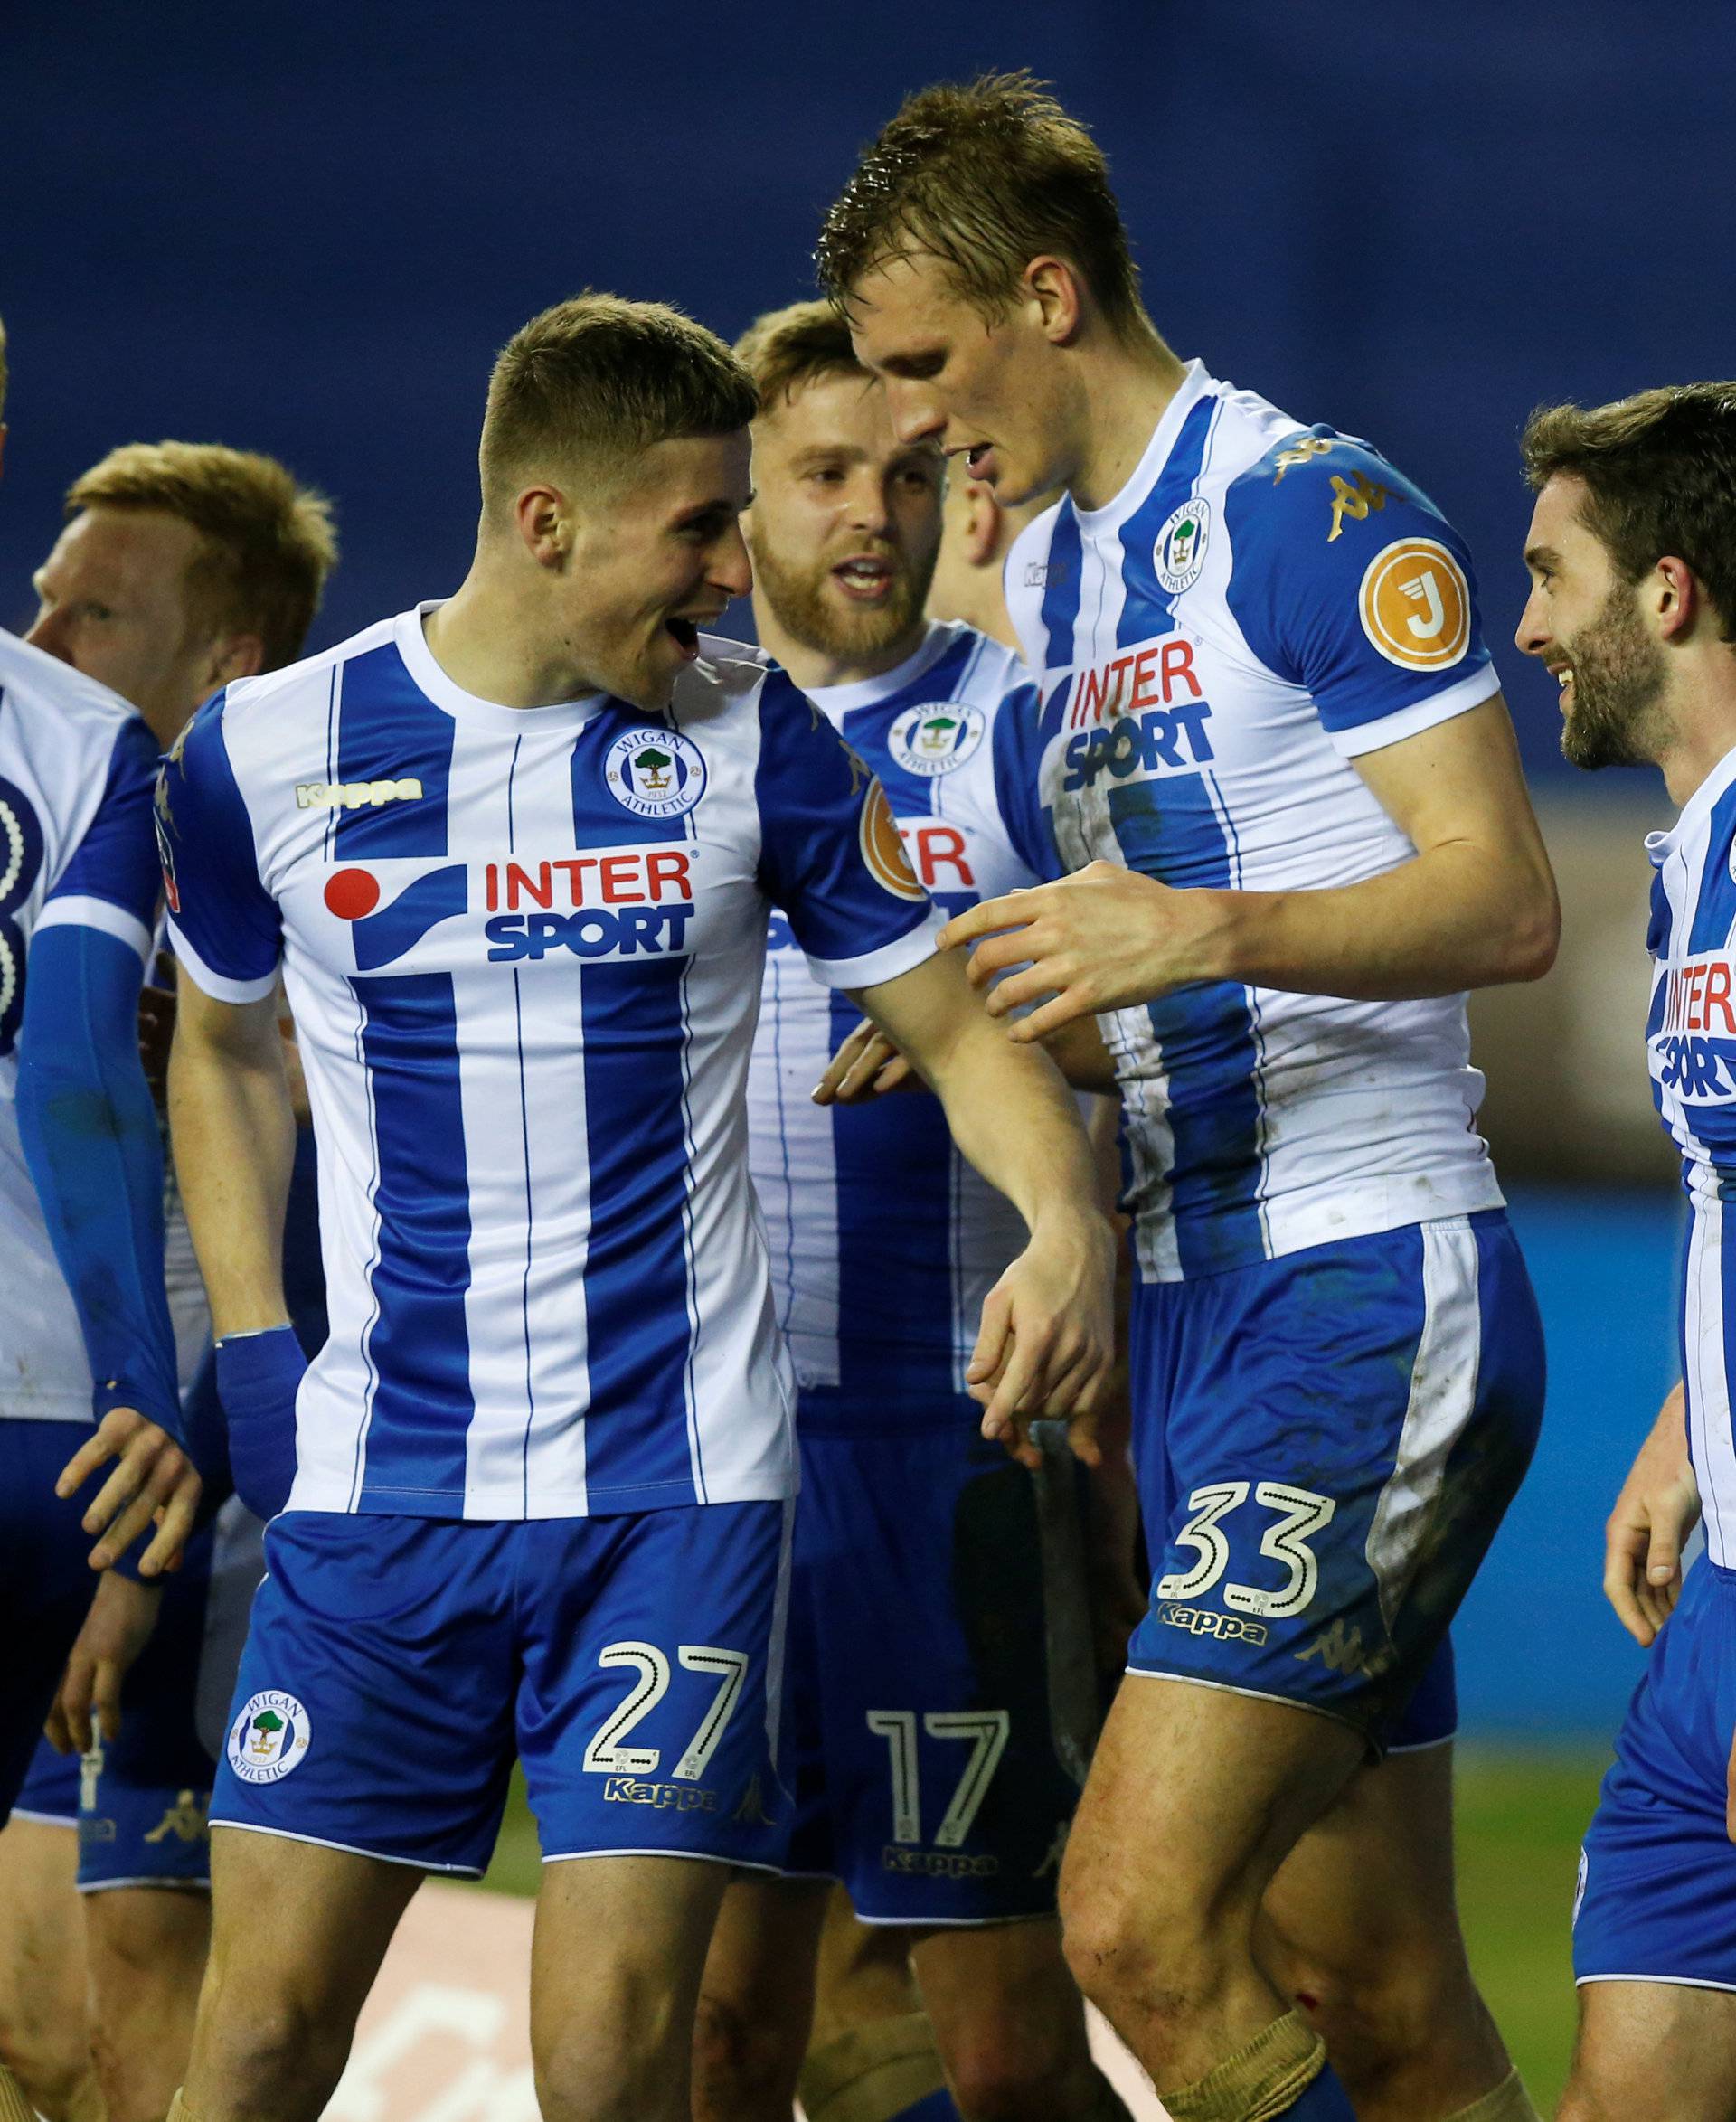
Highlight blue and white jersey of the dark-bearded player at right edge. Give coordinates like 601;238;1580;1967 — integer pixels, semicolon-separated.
1645;751;1736;1570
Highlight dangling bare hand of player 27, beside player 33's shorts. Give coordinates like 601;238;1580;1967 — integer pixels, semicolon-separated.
964;1210;1117;1468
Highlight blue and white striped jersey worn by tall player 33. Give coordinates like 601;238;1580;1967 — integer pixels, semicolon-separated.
1006;363;1500;1282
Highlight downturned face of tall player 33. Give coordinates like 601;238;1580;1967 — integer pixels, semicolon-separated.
849;252;1071;503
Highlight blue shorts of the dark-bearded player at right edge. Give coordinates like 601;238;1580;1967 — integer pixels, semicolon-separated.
1572;1555;1736;1990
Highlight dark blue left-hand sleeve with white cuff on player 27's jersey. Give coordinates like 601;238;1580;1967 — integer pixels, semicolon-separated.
157;692;282;1002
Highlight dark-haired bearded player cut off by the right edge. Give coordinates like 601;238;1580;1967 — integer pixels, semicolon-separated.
1517;382;1736;2122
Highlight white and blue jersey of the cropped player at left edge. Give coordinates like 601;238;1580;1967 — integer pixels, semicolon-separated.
0;632;157;1421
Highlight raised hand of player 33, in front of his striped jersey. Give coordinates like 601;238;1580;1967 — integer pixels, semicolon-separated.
940;862;1235;1044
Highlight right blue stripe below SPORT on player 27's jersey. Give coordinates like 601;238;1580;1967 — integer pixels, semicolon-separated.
581;957;703;1511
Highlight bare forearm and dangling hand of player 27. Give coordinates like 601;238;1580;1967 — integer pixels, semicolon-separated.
857;957;1114;1467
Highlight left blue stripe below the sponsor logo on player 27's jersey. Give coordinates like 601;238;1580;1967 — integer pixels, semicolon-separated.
350;972;476;1517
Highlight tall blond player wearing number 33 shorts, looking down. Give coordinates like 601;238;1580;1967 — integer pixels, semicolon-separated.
819;76;1555;2122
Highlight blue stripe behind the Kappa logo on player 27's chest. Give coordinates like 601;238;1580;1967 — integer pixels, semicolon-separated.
334;643;457;862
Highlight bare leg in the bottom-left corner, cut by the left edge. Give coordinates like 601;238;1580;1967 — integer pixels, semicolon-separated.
0;1799;90;2114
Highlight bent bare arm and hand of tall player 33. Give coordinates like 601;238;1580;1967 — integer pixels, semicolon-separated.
940;698;1560;1040
